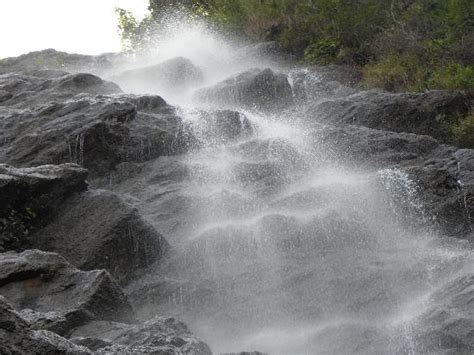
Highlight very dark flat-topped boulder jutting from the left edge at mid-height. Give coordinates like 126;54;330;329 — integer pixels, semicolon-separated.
0;164;87;251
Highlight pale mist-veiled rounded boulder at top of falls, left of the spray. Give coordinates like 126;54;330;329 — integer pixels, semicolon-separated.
112;57;203;93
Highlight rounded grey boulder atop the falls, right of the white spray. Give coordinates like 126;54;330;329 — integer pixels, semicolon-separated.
195;69;293;112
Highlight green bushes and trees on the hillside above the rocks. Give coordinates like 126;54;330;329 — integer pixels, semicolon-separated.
117;0;474;93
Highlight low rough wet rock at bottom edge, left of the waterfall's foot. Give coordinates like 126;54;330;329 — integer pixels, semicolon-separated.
71;317;211;355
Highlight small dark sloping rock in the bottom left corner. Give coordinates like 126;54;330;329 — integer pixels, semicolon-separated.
0;296;92;355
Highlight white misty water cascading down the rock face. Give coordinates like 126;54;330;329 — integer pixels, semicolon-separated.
112;18;474;354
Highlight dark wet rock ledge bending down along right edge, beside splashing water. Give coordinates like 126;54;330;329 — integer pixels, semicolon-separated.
314;125;474;239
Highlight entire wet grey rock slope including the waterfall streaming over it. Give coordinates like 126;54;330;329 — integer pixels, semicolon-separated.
0;43;474;355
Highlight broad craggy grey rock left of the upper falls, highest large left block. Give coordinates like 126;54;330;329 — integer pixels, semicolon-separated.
0;79;187;178
